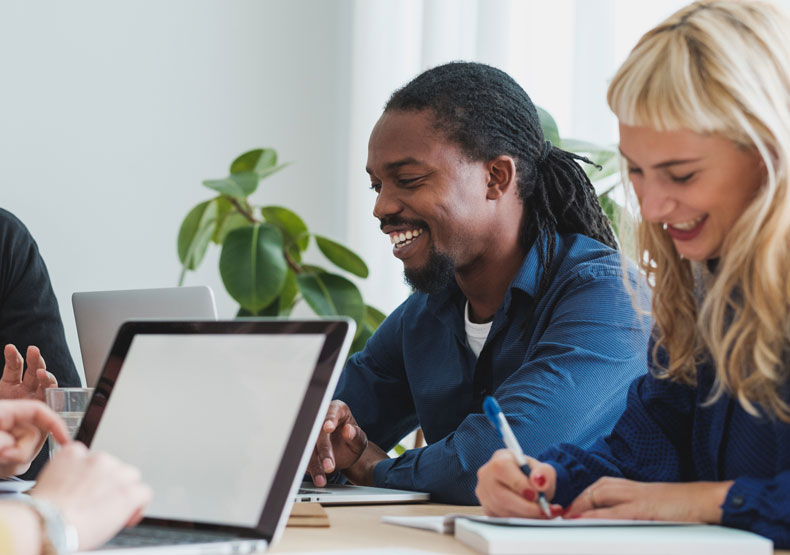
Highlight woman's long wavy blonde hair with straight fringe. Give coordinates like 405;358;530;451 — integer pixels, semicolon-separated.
607;0;790;422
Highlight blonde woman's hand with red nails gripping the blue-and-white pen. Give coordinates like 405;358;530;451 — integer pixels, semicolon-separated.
475;449;562;518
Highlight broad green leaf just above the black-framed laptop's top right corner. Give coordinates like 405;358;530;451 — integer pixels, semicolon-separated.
296;272;365;326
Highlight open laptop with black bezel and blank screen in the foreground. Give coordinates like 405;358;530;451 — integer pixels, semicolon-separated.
77;319;355;553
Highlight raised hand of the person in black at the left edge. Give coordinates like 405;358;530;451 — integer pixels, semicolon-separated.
0;345;58;401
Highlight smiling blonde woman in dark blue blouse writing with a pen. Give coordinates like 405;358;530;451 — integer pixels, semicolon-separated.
476;0;790;547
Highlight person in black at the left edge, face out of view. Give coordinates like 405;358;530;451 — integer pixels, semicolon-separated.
0;209;80;478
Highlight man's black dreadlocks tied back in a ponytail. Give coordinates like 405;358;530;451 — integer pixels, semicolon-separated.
384;62;617;296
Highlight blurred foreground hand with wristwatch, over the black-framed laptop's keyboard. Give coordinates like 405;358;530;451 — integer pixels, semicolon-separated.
32;442;151;550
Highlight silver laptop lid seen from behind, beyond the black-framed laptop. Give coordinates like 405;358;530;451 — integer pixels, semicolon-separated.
71;285;217;387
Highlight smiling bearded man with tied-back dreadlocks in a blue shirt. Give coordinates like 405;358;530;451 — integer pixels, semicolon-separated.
308;63;649;504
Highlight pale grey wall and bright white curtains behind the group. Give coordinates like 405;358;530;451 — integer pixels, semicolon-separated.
0;0;787;380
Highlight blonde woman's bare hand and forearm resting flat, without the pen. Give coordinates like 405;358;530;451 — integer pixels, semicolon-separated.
567;478;732;524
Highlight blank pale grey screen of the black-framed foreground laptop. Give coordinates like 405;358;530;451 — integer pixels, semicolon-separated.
91;334;325;527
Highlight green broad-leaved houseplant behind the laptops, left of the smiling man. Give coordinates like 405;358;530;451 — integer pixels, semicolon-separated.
178;148;384;352
